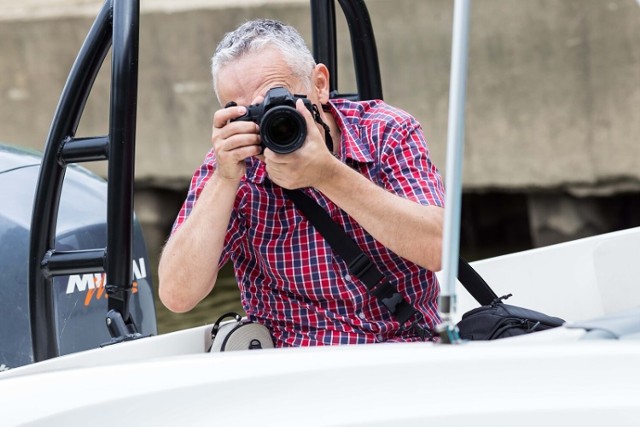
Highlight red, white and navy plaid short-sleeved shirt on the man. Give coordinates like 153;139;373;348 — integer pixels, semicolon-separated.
174;100;444;347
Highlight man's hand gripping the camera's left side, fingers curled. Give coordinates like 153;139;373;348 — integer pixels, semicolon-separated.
211;106;261;181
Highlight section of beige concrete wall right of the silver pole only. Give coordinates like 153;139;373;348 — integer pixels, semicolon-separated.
467;0;640;193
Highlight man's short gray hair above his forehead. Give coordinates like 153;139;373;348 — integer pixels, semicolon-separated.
211;19;316;95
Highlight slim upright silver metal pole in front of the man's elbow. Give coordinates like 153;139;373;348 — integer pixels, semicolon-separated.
439;0;470;343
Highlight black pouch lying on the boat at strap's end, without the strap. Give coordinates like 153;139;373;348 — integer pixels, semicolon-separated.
457;294;565;341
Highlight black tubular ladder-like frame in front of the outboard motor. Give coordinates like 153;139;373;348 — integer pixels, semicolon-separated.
29;0;140;362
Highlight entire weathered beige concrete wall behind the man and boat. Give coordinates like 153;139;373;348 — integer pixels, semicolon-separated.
0;0;640;193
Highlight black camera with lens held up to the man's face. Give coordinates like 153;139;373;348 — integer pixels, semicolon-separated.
232;87;313;154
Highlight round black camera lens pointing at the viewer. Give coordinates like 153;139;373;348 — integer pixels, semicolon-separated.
260;106;307;154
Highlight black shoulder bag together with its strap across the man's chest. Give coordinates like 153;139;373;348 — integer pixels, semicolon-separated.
284;189;564;340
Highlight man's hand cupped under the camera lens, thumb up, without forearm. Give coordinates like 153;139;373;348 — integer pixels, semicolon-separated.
263;99;337;189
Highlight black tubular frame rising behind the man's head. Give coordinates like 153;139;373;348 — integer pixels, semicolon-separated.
311;0;383;99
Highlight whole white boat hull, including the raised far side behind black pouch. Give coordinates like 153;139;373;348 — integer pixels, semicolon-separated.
0;229;640;427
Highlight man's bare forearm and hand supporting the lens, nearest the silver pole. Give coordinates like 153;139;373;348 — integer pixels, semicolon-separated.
265;102;444;271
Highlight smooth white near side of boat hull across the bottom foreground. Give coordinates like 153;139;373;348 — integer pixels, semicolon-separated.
0;328;640;426
